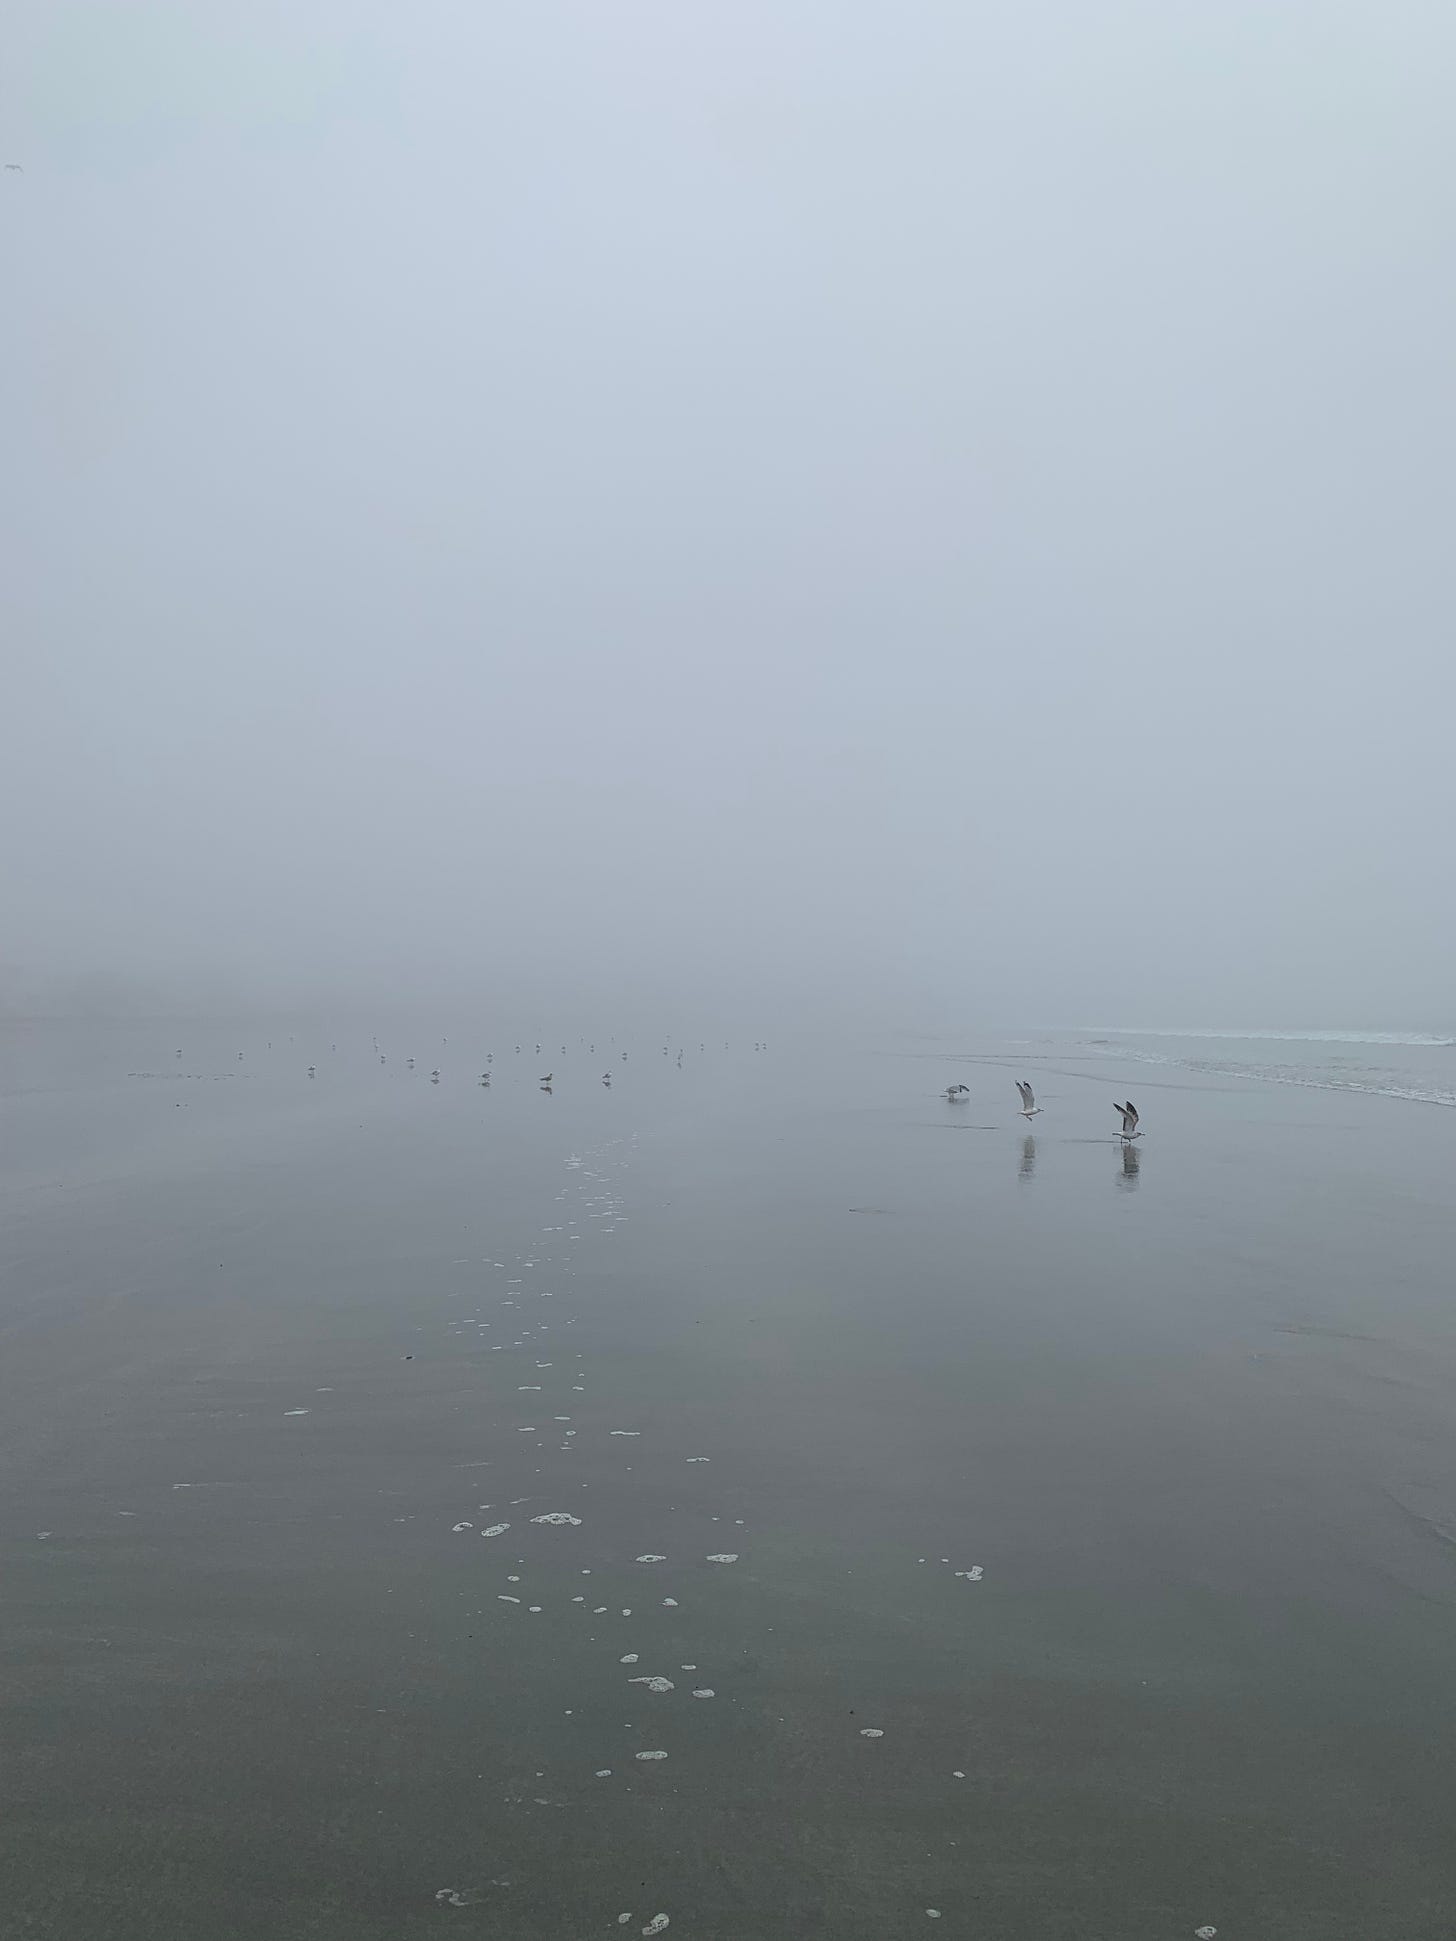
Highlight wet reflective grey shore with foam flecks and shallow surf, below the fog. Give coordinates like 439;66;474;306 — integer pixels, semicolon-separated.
0;1019;1456;1941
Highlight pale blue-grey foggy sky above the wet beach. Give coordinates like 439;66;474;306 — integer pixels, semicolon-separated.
0;0;1456;1025
